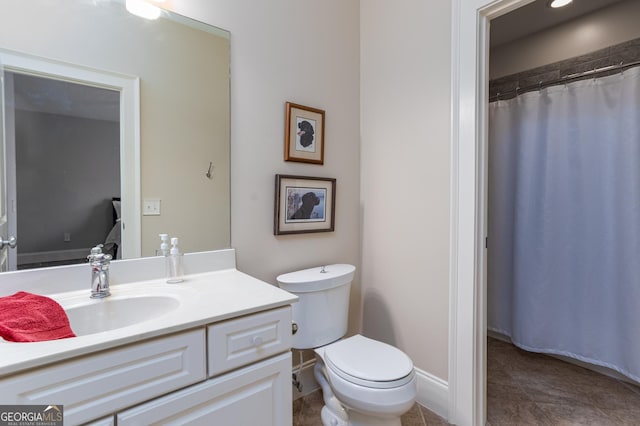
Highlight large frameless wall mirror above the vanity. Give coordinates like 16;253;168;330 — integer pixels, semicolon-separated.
0;0;230;269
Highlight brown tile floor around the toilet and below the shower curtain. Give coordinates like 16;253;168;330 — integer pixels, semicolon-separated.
293;339;640;426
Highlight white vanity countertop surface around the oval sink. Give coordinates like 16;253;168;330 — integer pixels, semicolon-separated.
0;269;297;378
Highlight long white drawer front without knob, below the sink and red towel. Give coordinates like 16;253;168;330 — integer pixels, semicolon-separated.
0;329;206;425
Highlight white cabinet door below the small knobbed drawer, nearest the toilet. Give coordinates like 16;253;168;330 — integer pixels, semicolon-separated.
117;352;292;426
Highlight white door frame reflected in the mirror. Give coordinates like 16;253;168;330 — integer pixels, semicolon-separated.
0;49;142;259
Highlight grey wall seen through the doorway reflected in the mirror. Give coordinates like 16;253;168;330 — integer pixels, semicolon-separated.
15;111;120;255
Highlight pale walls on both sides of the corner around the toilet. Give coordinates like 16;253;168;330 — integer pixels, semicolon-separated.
173;0;451;388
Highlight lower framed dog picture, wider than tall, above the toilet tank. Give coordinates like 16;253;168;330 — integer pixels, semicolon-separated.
273;175;336;235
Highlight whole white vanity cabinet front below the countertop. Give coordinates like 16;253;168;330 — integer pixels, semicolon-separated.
0;305;292;426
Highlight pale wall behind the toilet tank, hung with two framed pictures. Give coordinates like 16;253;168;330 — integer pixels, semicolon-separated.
171;0;360;331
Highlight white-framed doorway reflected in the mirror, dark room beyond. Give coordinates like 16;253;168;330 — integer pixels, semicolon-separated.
0;49;141;271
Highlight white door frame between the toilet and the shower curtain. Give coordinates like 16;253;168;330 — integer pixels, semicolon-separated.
449;0;534;426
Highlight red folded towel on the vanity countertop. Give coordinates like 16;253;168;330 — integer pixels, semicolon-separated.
0;291;76;342
